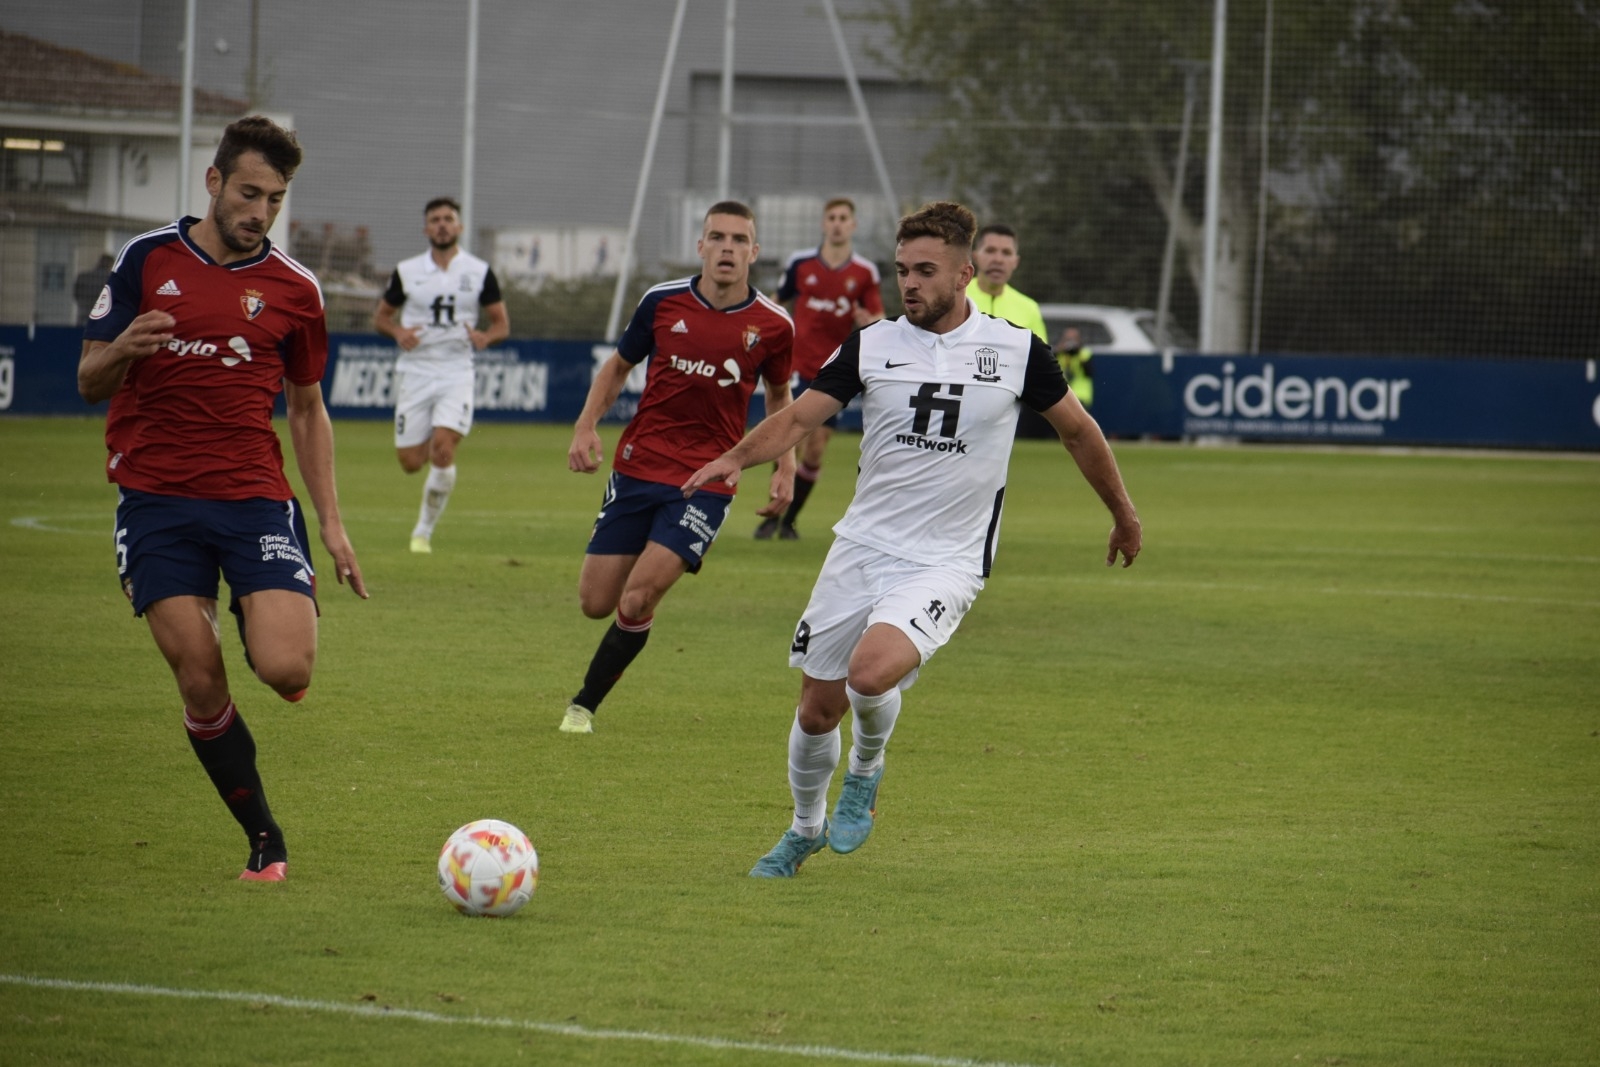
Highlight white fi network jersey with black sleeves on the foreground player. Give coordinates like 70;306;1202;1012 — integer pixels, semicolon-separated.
811;301;1067;577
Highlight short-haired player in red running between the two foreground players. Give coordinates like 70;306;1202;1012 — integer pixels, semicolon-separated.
560;200;794;734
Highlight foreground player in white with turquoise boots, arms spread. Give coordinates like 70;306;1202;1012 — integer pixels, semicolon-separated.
683;202;1142;878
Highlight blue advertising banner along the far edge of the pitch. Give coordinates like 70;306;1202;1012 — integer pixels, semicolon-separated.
0;326;1600;450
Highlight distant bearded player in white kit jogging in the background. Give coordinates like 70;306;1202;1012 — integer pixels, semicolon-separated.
373;197;510;552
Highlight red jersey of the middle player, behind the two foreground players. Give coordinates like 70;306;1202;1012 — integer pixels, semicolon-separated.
613;275;795;496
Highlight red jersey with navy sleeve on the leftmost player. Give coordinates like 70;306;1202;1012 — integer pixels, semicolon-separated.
83;218;328;501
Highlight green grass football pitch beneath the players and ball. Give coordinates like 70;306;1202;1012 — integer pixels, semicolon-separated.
0;418;1600;1067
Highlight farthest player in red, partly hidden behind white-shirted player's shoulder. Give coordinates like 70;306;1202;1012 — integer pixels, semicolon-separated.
755;197;883;541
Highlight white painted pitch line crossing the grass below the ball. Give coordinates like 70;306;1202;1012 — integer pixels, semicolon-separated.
0;974;1045;1067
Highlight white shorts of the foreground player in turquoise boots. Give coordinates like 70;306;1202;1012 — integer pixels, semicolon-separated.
789;537;984;689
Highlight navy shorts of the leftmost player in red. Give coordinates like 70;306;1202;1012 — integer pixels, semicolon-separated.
117;490;317;616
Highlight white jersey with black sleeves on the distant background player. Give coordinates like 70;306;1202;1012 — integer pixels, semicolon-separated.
384;250;502;373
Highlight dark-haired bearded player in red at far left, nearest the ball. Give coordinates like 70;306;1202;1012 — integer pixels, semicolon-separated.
78;115;366;881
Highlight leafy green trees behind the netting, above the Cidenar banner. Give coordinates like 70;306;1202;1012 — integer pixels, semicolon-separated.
878;0;1600;354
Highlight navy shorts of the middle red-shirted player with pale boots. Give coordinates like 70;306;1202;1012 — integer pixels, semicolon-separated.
586;470;733;574
